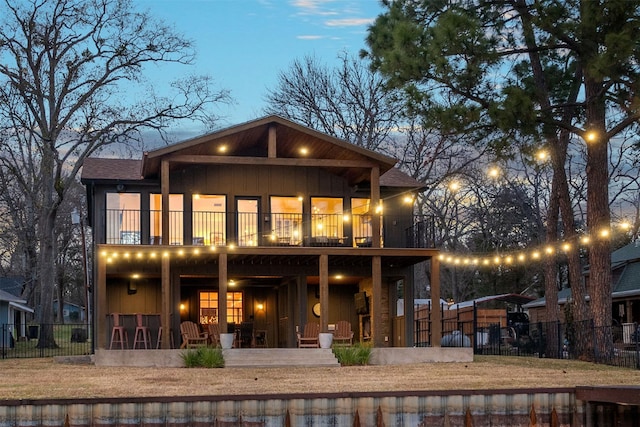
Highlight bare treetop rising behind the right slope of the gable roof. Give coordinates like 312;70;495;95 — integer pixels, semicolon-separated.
265;53;402;152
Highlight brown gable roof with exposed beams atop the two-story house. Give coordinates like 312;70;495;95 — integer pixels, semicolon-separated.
81;116;424;189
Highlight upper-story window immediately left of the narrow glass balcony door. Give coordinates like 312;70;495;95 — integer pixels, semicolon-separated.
192;194;227;246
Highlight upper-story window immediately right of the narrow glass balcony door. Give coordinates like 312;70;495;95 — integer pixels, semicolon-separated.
269;196;302;245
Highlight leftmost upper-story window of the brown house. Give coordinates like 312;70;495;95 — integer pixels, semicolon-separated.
105;193;140;245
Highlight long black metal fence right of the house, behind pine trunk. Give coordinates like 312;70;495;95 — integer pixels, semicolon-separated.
415;310;640;369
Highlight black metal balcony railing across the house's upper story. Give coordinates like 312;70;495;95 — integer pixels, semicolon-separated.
104;209;434;248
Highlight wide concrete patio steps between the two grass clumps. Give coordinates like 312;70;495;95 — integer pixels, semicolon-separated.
222;348;340;368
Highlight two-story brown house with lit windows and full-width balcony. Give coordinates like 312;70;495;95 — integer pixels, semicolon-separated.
81;116;440;349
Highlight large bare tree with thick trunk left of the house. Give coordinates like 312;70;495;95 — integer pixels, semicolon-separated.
0;0;228;348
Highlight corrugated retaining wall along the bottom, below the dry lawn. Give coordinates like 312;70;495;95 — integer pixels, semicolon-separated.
0;388;585;427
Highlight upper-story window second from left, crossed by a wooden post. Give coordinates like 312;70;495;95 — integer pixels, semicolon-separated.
149;194;184;245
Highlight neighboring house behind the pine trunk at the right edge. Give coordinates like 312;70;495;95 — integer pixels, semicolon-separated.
523;241;640;325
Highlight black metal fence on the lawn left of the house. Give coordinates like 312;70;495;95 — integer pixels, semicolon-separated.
0;323;93;359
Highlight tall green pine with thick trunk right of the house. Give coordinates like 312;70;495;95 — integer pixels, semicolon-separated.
363;0;640;357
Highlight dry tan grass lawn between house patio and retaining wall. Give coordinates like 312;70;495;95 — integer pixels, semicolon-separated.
0;356;640;399
